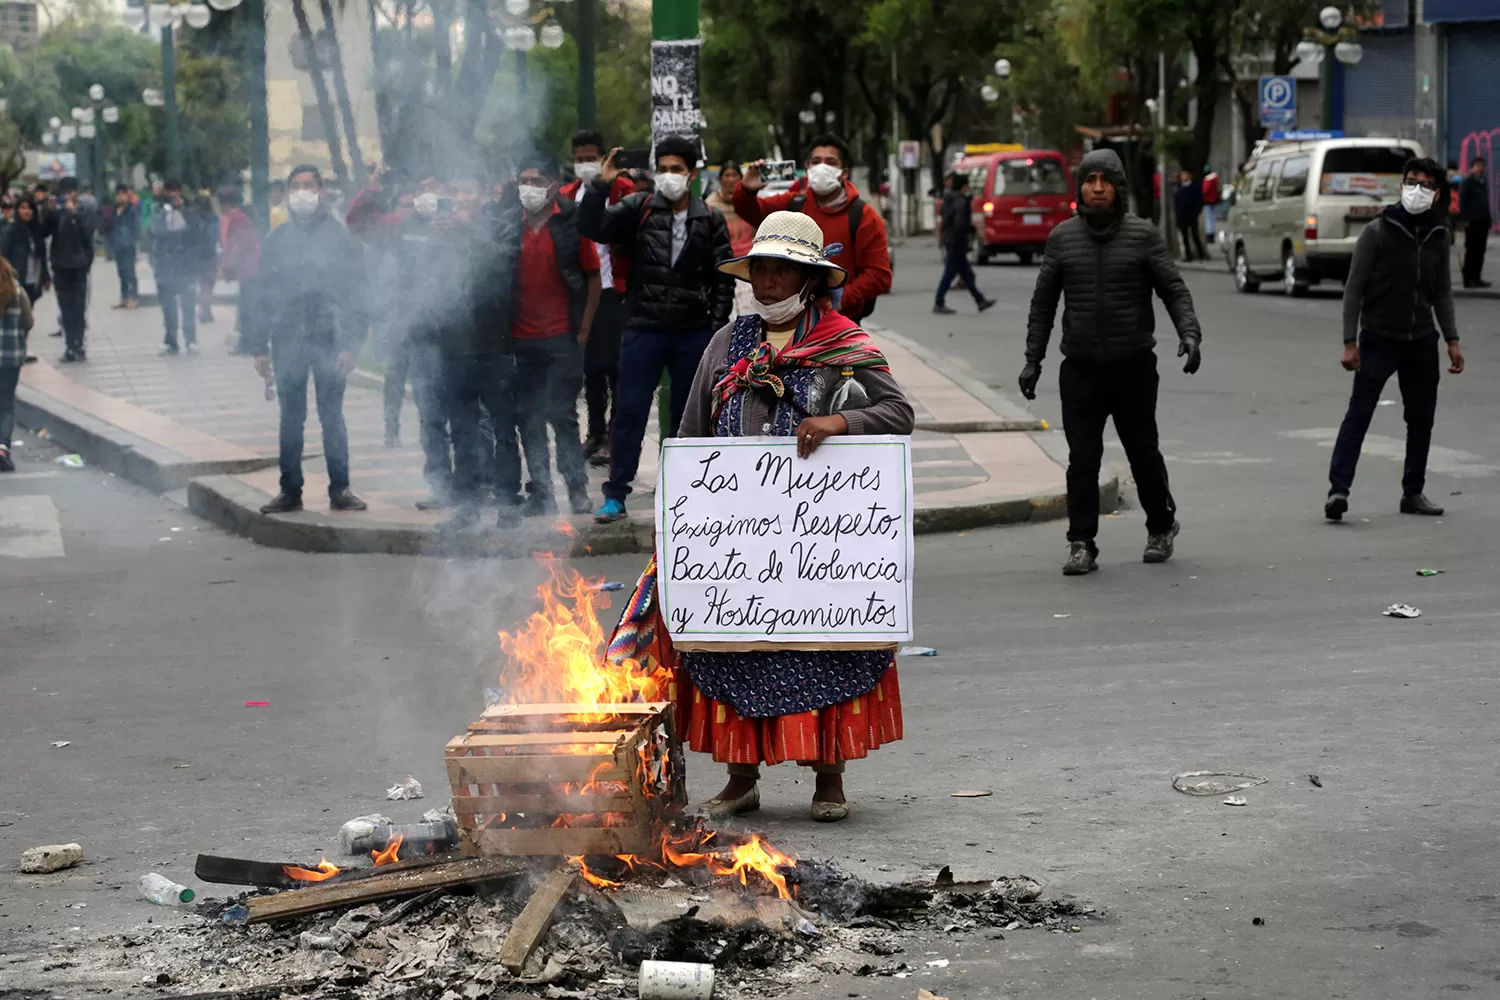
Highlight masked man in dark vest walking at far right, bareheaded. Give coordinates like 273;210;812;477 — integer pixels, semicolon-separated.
1323;157;1464;520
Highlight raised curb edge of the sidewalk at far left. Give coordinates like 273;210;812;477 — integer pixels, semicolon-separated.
15;384;276;493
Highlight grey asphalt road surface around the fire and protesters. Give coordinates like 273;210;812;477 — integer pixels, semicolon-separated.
0;247;1500;1000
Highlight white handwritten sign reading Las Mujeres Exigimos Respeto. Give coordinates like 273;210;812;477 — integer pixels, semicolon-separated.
657;435;912;646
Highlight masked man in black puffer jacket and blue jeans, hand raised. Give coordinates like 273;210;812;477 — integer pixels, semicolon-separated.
578;135;735;522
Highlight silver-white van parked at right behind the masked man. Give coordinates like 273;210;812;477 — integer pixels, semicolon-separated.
1224;138;1422;295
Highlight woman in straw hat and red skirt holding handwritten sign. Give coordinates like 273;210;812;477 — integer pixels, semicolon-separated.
609;211;915;823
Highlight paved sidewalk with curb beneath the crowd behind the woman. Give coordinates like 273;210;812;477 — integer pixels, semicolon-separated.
17;261;1118;555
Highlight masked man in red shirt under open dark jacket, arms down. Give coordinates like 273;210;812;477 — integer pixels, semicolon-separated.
513;156;600;516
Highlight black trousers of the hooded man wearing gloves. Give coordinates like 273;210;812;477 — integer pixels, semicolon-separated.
1058;351;1178;544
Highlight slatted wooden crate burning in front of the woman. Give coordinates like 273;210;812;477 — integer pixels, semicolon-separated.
446;702;687;856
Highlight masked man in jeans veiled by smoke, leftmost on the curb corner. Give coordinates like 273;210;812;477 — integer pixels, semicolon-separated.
242;165;366;514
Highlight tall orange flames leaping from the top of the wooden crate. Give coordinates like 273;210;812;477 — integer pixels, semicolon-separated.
500;556;671;715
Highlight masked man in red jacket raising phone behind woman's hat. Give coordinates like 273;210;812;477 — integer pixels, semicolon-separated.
735;132;891;322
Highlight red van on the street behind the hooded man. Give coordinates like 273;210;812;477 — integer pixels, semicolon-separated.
954;150;1079;264
